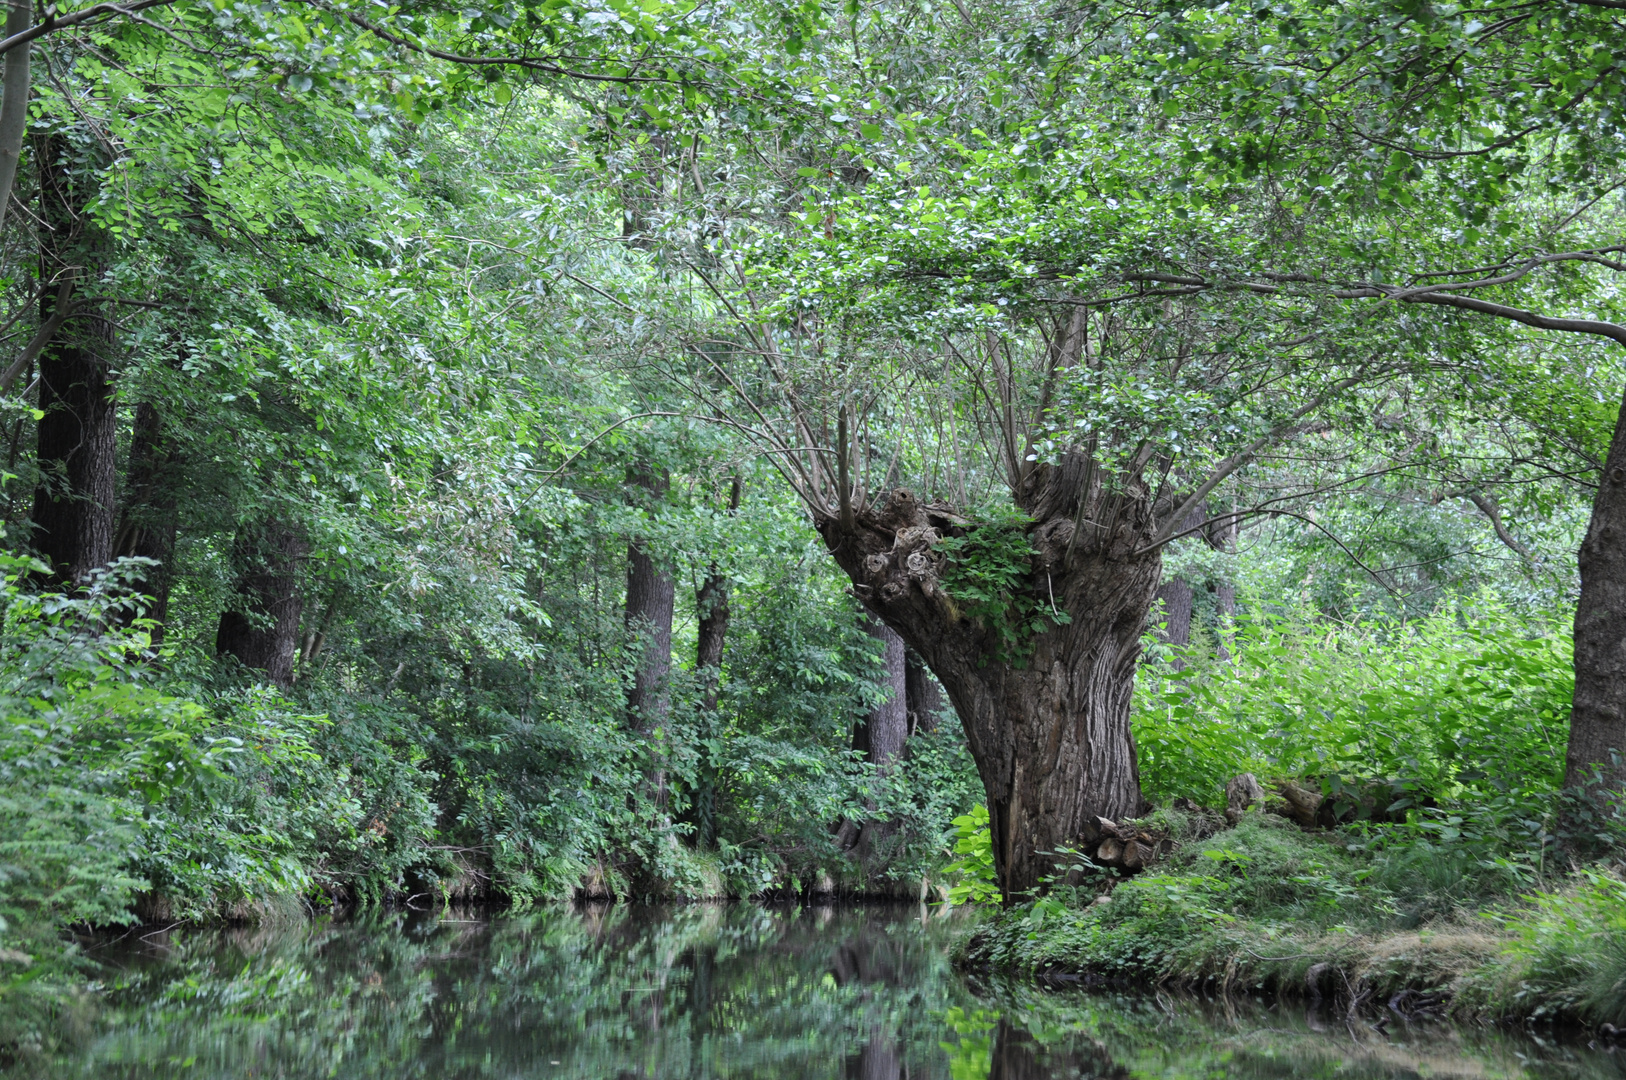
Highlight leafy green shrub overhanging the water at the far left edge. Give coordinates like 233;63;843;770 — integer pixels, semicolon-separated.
0;556;217;1047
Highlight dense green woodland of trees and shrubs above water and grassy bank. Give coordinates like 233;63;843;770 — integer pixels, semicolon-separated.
0;0;1626;1047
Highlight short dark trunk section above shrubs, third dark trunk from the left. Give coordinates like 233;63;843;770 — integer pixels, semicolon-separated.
215;520;309;690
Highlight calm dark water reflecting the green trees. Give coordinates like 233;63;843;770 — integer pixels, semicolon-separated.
49;904;1626;1080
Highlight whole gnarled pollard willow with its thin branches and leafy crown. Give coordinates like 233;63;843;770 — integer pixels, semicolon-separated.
673;158;1457;898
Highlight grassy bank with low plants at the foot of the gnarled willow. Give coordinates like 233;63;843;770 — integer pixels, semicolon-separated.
958;812;1626;1028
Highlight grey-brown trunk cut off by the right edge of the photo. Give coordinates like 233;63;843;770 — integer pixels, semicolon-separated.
1564;391;1626;799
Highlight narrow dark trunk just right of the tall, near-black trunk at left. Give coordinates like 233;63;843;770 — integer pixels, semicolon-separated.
114;402;177;646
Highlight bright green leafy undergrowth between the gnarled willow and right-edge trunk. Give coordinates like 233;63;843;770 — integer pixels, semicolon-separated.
1135;597;1574;865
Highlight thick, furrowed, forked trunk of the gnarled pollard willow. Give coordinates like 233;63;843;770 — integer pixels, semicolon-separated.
815;454;1161;903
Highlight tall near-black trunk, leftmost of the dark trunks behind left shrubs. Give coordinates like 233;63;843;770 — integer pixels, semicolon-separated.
33;137;117;587
